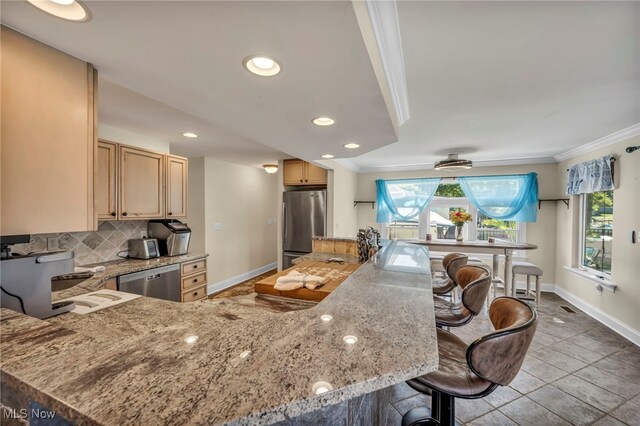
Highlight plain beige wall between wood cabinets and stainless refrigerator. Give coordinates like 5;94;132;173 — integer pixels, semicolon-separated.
202;158;278;285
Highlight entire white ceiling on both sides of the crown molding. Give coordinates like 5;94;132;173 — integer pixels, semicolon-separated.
2;0;640;171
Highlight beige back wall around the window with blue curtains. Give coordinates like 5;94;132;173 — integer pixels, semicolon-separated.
356;164;565;284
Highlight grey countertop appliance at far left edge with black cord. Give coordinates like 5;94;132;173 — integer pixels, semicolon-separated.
0;251;75;319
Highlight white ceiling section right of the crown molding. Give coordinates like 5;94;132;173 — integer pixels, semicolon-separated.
351;1;640;171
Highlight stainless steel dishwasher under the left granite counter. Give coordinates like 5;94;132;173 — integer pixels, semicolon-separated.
118;263;180;302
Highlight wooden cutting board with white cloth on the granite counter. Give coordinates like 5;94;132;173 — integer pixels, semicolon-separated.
255;260;360;302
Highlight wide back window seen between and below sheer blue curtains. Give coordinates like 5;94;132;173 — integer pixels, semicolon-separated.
382;183;526;241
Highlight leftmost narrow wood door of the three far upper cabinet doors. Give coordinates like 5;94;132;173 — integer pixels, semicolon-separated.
95;141;118;220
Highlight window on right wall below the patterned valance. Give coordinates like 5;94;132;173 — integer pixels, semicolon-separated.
580;191;613;274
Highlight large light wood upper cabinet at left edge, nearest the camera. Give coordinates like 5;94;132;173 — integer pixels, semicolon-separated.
0;26;97;235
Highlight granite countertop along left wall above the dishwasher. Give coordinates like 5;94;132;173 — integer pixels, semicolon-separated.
52;253;209;302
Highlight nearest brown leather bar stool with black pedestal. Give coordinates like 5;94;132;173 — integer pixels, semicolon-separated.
402;296;538;426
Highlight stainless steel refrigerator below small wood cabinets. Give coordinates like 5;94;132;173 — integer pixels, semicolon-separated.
282;190;327;269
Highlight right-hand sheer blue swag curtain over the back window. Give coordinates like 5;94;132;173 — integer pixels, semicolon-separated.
458;173;538;222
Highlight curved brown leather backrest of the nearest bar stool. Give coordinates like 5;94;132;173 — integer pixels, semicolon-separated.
467;297;538;386
